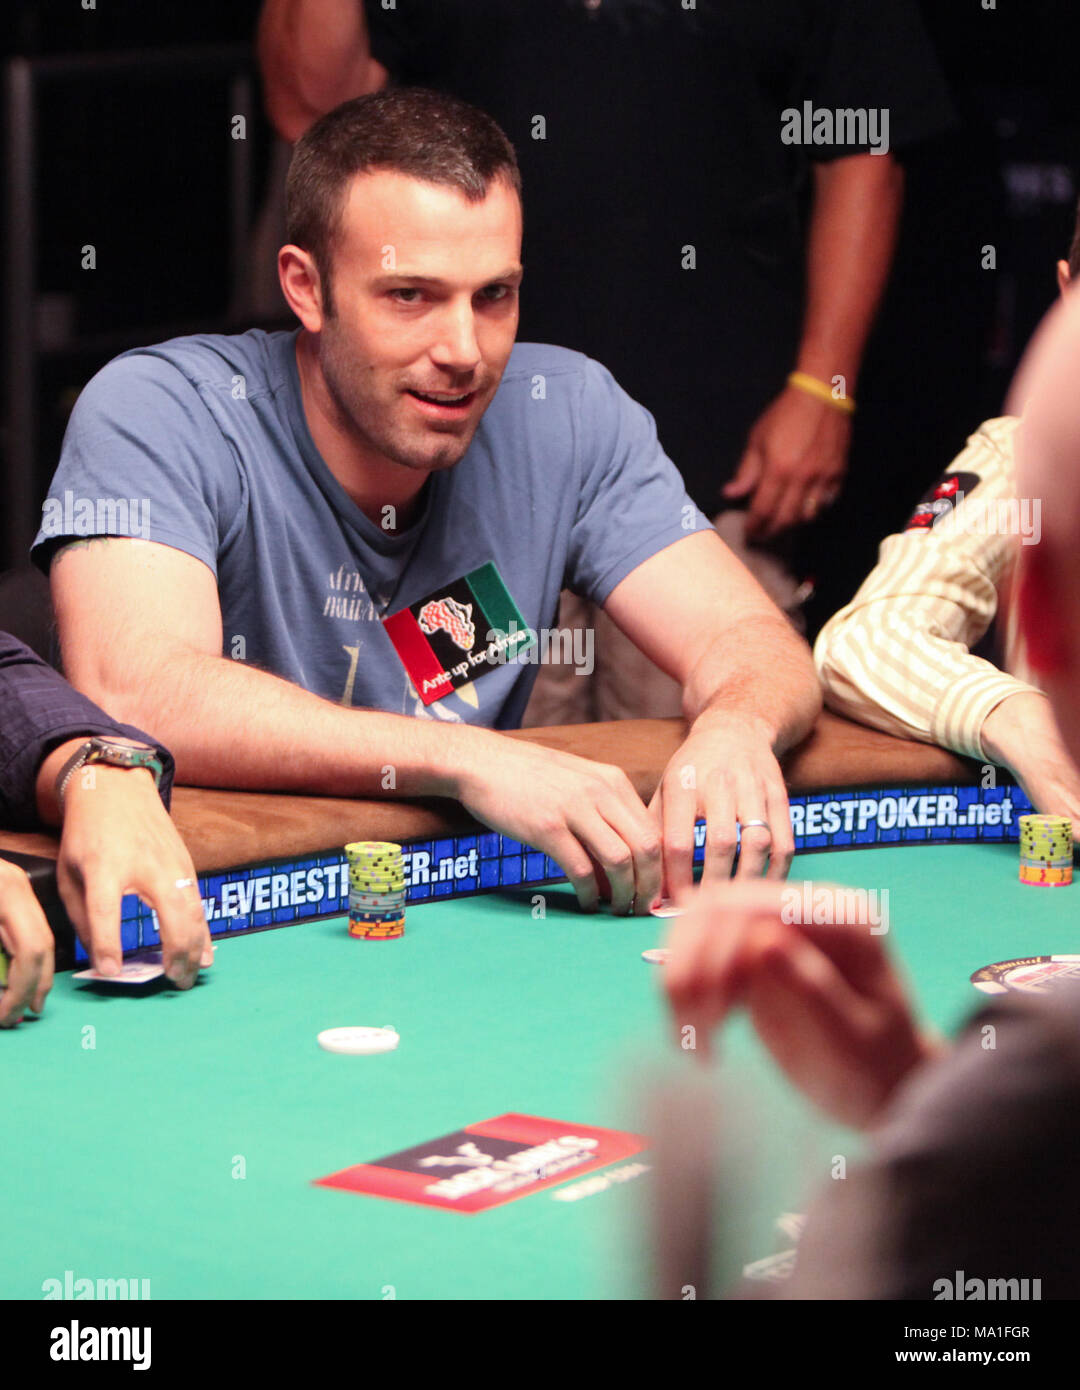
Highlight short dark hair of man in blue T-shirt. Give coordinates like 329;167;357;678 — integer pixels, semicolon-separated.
285;88;521;314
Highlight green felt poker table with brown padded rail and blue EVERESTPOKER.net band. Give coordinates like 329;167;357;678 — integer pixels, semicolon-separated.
0;714;1080;1300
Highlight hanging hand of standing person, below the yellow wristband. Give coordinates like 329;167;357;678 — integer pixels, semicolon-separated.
723;386;851;539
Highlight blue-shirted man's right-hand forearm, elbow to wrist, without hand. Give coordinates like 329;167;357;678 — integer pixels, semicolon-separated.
682;616;821;755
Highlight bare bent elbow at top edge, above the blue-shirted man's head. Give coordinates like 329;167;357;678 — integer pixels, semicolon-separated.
256;0;386;143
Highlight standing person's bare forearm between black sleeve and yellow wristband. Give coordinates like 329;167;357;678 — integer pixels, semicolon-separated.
796;154;903;396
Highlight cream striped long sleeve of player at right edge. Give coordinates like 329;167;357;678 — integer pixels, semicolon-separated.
815;418;1034;759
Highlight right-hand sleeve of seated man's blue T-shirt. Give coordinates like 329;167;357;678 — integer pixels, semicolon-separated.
564;359;712;605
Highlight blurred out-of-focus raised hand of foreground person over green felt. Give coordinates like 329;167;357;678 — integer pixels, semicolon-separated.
663;883;937;1127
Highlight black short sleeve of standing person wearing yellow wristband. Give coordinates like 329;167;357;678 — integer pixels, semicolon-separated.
801;0;955;163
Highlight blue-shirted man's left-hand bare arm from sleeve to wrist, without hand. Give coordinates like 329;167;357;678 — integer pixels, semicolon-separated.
51;538;475;796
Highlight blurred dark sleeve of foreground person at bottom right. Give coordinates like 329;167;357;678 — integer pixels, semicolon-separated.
788;986;1080;1300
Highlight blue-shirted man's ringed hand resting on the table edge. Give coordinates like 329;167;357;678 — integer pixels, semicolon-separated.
649;710;795;898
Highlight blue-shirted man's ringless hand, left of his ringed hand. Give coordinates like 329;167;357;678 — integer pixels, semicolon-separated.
456;735;662;915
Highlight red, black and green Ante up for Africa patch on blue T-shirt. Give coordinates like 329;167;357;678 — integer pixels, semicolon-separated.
382;560;537;705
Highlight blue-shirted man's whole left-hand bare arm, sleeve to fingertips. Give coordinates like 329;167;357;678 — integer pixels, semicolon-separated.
51;538;662;912
